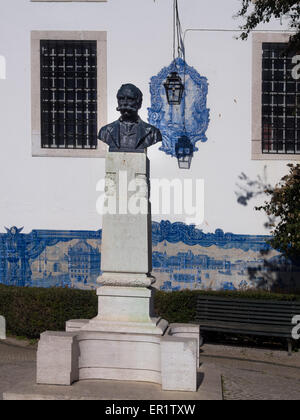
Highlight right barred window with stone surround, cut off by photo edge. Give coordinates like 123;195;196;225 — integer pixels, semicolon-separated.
252;33;300;160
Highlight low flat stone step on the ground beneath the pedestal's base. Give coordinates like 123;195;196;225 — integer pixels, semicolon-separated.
3;363;222;400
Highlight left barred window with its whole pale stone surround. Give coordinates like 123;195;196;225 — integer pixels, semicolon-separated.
32;31;106;157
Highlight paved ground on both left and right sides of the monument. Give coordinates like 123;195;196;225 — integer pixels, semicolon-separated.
0;339;300;400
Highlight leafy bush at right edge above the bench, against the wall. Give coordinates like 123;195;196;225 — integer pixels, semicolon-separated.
256;164;300;264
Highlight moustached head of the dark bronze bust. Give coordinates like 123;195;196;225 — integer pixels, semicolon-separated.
117;83;143;121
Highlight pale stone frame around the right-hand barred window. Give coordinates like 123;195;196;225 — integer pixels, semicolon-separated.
251;32;300;161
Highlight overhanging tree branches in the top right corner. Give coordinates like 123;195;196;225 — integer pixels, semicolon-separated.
237;0;300;49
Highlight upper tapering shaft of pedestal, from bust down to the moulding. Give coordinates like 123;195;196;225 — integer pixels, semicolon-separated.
99;153;152;278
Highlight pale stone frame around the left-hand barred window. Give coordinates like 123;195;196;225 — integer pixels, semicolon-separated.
31;31;107;158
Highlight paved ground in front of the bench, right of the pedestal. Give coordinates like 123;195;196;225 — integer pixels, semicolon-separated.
201;344;300;400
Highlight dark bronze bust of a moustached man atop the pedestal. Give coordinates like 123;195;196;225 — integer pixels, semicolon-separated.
98;84;162;153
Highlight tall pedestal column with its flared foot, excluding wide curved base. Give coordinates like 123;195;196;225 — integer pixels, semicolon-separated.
84;153;168;334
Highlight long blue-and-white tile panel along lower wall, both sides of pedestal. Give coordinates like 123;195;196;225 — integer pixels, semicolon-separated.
0;221;300;291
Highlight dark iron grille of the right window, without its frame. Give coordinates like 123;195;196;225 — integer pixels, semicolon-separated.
262;43;300;154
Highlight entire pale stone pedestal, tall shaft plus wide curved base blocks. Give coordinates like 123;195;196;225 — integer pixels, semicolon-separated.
37;153;199;391
